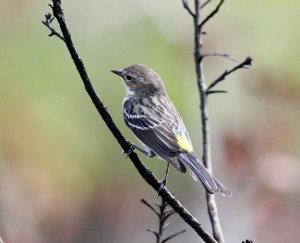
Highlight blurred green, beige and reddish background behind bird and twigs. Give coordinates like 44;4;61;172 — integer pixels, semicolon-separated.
0;0;300;243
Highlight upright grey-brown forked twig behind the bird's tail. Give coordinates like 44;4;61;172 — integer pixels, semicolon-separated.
183;0;251;243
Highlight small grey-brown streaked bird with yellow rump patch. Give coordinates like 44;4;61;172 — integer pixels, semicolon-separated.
111;64;231;195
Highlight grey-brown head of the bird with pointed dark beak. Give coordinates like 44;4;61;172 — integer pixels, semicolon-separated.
111;64;165;96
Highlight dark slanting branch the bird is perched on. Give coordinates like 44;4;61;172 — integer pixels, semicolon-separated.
44;0;216;243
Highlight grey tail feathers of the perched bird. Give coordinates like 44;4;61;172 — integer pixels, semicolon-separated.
177;152;231;196
